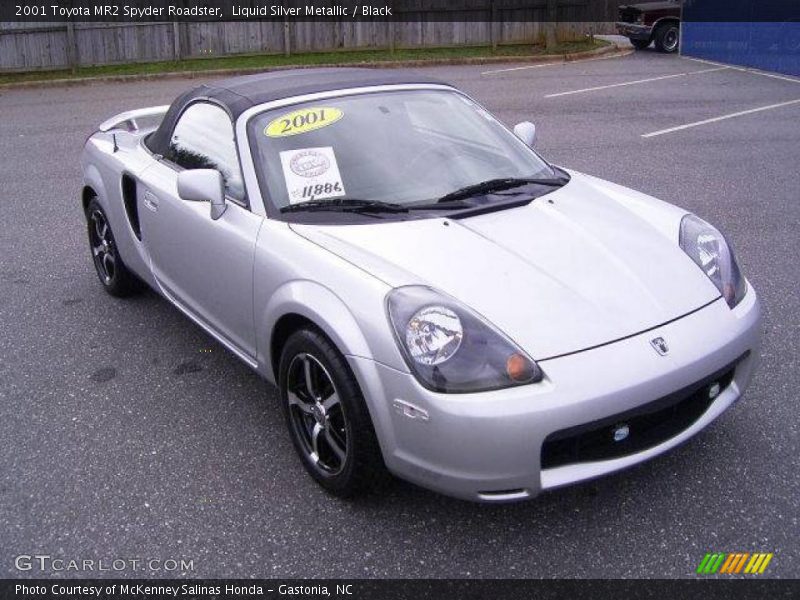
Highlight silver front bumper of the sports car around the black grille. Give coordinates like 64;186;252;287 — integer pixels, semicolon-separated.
349;287;761;502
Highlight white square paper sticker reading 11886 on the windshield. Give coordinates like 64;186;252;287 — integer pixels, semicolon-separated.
280;146;345;204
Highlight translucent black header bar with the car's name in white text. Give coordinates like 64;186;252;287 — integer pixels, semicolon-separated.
0;0;800;23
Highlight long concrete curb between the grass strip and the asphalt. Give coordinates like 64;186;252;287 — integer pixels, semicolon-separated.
0;42;633;90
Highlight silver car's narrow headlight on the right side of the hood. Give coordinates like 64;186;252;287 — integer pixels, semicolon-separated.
680;215;747;308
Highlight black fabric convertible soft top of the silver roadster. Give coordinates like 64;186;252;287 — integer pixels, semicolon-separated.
147;68;444;154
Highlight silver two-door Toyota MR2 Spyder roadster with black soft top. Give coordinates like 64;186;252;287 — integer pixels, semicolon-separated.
82;69;760;502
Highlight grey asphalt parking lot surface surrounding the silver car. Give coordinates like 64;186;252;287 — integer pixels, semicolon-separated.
0;44;800;577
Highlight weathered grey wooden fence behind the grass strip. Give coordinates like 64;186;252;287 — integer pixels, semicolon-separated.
0;0;618;72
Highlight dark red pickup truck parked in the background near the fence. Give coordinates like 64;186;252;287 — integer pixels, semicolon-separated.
617;0;681;52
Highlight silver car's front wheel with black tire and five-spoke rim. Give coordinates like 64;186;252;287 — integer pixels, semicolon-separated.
278;328;391;498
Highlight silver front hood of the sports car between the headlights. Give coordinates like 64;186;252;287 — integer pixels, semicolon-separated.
292;173;719;360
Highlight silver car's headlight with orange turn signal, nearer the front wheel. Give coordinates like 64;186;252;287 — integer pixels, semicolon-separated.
387;286;542;393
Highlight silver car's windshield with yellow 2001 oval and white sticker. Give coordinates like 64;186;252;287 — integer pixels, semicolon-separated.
249;90;555;209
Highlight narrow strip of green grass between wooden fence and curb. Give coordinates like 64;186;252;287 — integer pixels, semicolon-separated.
0;38;608;84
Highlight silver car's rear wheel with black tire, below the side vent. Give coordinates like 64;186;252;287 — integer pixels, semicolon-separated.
86;198;143;298
